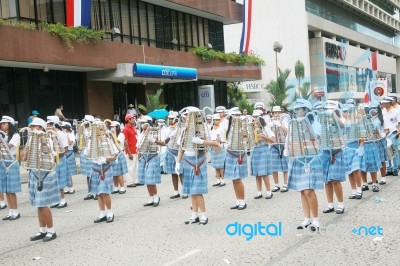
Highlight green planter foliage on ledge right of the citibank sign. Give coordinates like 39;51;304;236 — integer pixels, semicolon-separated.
191;46;265;66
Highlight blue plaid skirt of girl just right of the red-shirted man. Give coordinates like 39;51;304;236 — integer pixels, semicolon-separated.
138;153;161;185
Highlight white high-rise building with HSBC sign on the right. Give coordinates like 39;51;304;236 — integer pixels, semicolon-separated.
225;0;400;107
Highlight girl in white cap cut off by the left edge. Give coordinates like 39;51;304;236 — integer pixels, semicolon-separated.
0;116;21;221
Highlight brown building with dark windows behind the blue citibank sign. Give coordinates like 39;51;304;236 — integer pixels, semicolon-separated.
0;0;261;126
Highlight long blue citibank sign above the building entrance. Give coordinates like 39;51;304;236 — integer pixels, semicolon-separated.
133;63;197;80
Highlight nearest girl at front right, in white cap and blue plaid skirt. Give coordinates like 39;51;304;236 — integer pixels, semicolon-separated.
285;99;324;231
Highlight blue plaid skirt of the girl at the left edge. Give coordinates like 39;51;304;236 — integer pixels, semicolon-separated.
0;161;21;193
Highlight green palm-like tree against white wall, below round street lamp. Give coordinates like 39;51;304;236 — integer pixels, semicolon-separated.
265;69;294;107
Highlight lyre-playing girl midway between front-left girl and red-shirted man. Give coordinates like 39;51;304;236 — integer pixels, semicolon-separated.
85;121;118;223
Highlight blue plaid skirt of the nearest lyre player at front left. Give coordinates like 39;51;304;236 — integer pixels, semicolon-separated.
28;170;61;207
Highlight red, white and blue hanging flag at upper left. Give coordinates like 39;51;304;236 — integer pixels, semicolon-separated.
66;0;92;28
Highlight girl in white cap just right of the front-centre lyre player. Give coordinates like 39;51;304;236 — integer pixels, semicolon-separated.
209;114;226;187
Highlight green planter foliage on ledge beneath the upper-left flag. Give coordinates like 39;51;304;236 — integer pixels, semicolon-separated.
43;22;104;52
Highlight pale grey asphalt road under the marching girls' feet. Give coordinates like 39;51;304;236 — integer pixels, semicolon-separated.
0;160;400;265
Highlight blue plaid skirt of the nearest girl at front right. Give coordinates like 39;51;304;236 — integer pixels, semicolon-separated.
288;157;325;191
